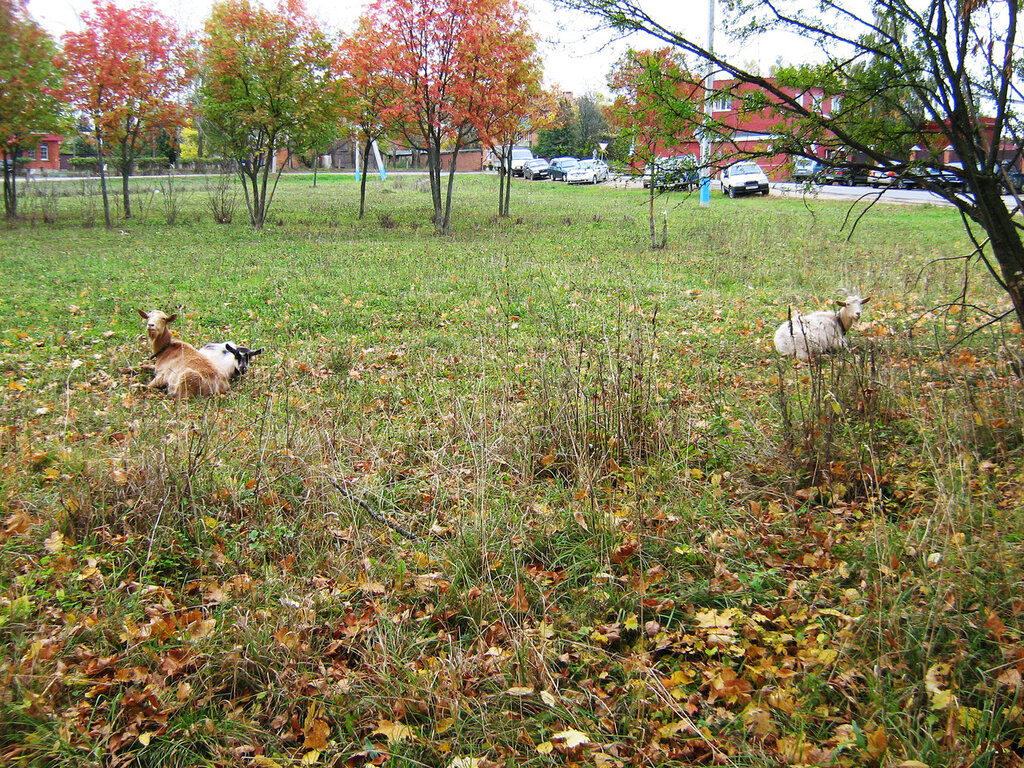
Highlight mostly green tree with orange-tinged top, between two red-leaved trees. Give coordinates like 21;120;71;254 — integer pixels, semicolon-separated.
201;0;342;229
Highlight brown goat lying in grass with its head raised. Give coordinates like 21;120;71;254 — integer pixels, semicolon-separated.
138;309;230;397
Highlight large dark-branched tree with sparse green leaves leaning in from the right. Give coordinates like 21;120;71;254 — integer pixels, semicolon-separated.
558;0;1024;329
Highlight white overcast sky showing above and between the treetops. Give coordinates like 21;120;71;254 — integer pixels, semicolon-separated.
28;0;806;95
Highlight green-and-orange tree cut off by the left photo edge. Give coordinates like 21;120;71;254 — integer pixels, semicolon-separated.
0;0;63;219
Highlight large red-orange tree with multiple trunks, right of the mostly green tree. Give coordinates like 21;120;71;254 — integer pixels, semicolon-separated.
366;0;534;233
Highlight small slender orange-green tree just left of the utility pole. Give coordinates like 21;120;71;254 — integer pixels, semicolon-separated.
608;48;700;248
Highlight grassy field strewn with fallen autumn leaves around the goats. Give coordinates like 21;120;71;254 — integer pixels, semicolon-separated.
0;176;1024;768
